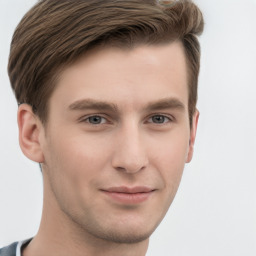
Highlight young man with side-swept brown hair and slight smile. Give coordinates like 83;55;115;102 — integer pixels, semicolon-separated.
0;0;203;256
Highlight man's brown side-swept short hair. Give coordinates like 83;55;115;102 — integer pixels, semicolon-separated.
8;0;204;124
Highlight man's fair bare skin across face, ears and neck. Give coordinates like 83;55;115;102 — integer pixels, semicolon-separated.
18;42;199;256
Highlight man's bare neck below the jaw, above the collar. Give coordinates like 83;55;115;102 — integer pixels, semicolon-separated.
22;180;149;256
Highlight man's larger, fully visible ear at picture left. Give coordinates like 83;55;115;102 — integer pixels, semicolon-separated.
17;104;44;163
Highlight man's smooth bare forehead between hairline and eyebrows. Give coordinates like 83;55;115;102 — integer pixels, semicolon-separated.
50;42;188;112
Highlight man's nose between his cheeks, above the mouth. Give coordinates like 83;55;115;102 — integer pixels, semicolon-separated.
112;126;148;174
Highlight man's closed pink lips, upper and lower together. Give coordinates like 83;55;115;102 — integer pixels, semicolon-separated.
101;186;155;204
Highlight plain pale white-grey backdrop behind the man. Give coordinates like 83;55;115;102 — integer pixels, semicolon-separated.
0;0;256;256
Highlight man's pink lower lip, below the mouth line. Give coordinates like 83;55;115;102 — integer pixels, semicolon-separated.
103;191;153;204
